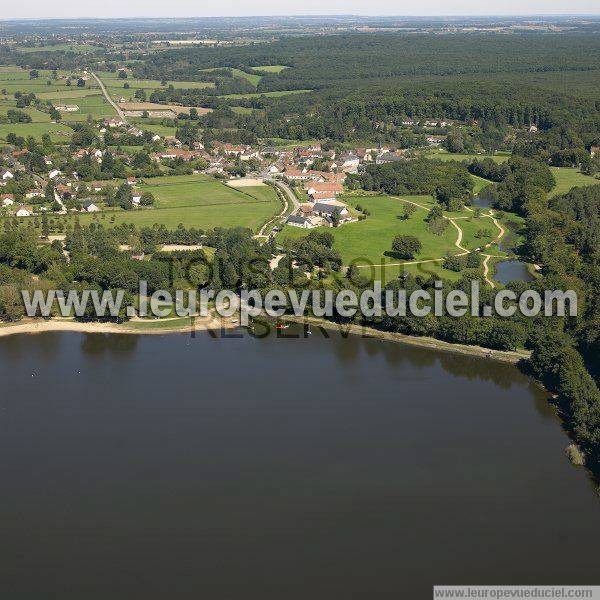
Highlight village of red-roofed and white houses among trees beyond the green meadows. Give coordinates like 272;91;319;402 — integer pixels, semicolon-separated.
0;112;464;229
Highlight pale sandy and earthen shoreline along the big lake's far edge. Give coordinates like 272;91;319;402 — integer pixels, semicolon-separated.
0;315;530;365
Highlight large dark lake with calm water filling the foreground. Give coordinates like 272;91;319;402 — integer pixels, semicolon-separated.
0;330;600;600
